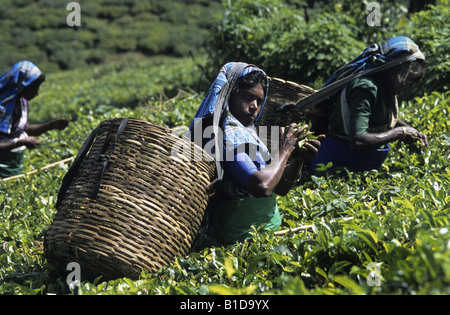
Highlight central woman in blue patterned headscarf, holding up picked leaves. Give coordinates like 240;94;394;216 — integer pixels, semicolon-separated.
190;63;320;247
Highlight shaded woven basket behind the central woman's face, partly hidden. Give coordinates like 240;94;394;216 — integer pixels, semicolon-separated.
257;78;332;139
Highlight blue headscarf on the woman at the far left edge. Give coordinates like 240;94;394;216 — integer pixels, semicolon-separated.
0;61;42;133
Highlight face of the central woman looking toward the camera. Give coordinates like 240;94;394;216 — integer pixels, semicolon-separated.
229;83;265;127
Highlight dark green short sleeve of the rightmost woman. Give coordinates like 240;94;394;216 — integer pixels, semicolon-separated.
347;79;378;136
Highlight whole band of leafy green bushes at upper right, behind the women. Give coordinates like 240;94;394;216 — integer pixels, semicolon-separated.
206;0;450;92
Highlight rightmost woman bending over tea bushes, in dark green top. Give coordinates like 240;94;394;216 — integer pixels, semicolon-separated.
311;36;428;171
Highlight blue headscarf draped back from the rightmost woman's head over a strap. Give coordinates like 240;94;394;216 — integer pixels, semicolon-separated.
324;36;425;87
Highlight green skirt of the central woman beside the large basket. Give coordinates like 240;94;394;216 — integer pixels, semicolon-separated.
195;197;281;248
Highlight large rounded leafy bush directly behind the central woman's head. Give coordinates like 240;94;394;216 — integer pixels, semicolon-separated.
206;0;364;84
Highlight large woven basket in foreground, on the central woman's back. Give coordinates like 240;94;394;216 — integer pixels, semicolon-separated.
44;119;215;279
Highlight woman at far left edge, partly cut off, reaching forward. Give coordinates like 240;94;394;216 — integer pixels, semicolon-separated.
0;61;68;178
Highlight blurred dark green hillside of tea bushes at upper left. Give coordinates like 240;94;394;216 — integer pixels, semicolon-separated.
0;0;223;72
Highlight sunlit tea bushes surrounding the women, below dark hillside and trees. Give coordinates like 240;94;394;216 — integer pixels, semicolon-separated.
0;59;450;295
